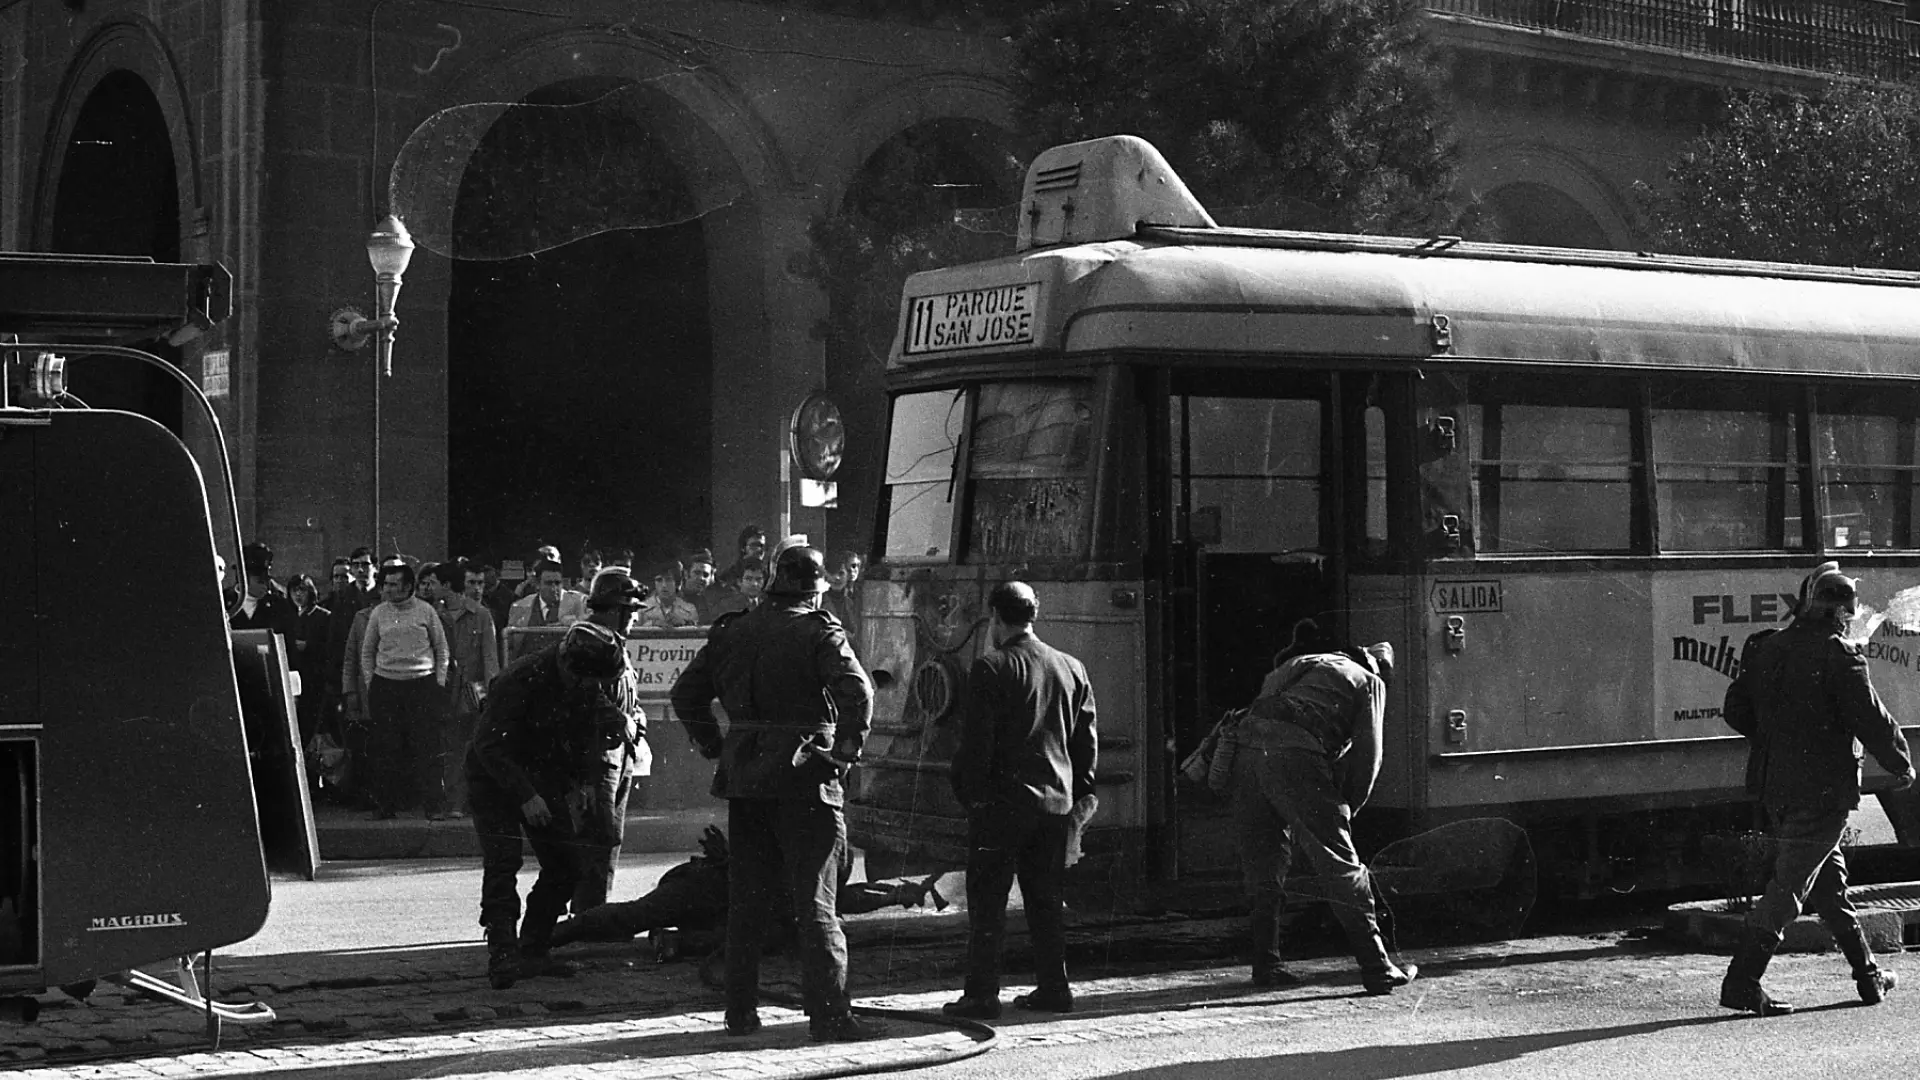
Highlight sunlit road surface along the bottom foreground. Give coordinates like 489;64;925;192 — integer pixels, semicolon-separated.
25;936;1920;1080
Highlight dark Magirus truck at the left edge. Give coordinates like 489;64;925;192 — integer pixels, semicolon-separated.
0;254;273;1032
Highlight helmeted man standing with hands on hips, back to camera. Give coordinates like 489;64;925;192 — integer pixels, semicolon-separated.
672;546;881;1042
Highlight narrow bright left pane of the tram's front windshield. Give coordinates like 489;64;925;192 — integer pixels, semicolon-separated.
887;390;966;561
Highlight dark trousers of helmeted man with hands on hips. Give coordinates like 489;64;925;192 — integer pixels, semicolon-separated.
726;799;847;1020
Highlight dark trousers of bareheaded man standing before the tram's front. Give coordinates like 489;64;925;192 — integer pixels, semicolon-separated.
966;801;1073;997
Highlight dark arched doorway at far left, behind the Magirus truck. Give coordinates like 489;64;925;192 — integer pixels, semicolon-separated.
50;71;182;434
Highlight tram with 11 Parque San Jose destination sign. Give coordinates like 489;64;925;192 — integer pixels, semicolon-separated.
849;136;1920;896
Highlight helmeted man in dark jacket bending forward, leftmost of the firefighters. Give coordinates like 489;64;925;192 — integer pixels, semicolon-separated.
467;623;626;990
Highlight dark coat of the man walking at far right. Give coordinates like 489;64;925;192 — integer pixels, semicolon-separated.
1722;619;1908;811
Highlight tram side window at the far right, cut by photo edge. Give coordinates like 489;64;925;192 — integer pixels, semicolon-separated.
1814;413;1920;548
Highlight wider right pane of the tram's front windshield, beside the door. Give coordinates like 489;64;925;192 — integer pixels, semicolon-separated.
966;380;1094;561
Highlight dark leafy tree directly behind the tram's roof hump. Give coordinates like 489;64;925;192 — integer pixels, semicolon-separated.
1014;0;1455;234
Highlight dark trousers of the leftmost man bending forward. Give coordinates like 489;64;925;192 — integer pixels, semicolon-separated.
467;769;580;944
